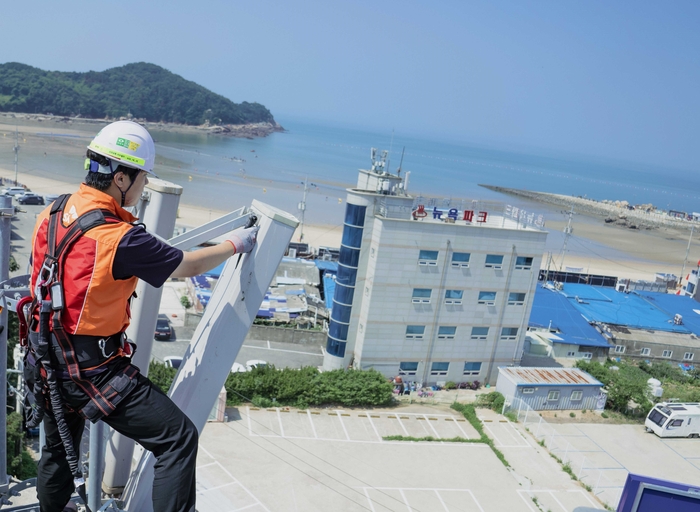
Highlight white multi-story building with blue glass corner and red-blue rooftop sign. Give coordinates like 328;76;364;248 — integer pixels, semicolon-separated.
323;154;547;384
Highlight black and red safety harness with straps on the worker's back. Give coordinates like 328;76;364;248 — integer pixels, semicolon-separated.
17;194;138;510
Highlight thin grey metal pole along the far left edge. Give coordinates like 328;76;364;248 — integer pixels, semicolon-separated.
0;195;14;494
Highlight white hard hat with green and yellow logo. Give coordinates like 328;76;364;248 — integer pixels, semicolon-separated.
88;121;156;176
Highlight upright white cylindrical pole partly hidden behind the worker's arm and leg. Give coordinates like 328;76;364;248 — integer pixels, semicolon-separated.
102;179;182;496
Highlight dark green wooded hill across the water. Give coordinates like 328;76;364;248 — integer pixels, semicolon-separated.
0;62;275;125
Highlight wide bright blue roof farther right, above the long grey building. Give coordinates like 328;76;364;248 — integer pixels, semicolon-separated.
562;283;688;334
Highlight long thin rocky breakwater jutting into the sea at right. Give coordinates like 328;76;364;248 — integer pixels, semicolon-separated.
479;184;700;230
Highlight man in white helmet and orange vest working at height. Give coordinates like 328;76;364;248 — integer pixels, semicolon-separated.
29;121;258;512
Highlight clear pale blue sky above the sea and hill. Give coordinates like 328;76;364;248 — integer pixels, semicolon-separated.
0;0;700;170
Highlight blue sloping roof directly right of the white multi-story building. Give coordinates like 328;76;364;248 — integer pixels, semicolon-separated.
529;285;610;347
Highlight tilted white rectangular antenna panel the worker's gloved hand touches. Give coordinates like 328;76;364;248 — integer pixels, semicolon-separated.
122;201;299;512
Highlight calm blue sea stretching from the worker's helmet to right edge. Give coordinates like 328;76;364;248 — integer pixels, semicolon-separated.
149;119;700;219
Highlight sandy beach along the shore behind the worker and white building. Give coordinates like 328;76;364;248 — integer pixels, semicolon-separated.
0;115;700;288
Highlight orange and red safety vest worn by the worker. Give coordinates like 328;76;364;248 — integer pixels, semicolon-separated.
30;184;138;336
